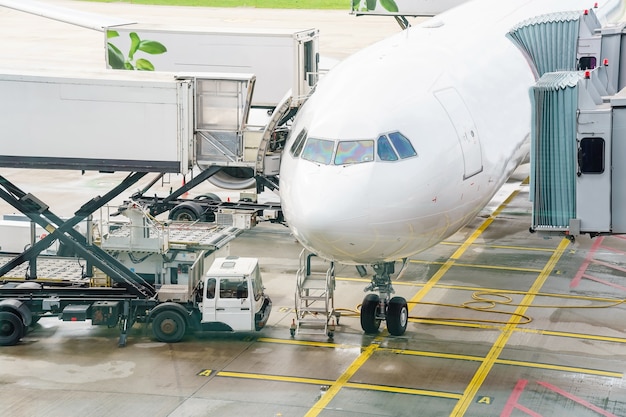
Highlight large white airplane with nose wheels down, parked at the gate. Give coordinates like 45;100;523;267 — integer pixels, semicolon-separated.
280;0;623;335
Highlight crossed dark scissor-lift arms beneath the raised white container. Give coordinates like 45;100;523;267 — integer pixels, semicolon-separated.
0;173;154;297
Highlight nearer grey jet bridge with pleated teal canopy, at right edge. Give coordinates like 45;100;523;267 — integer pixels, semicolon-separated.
530;12;626;238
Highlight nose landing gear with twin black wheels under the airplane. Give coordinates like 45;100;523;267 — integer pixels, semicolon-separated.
361;262;409;336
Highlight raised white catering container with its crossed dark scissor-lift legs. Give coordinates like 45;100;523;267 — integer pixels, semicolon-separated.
0;70;278;288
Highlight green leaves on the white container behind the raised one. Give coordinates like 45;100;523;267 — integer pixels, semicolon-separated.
107;30;167;71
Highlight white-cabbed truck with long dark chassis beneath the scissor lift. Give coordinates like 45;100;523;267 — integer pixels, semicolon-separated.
0;256;272;346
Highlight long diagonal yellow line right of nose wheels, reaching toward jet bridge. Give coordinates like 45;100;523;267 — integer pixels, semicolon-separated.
450;239;569;417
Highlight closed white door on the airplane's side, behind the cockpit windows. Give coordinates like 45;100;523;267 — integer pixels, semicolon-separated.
435;88;483;179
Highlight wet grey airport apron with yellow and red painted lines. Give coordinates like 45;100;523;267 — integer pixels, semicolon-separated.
0;1;626;417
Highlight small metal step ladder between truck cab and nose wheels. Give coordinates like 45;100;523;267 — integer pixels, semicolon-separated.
292;249;338;339
